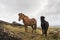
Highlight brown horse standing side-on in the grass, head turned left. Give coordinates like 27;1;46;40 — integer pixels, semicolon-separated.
18;13;37;32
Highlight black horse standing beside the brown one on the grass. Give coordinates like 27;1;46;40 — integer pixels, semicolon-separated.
40;16;49;36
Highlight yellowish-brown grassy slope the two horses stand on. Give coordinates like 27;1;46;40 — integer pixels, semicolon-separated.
0;22;60;40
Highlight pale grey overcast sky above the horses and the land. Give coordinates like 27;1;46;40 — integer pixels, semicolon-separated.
0;0;60;26
